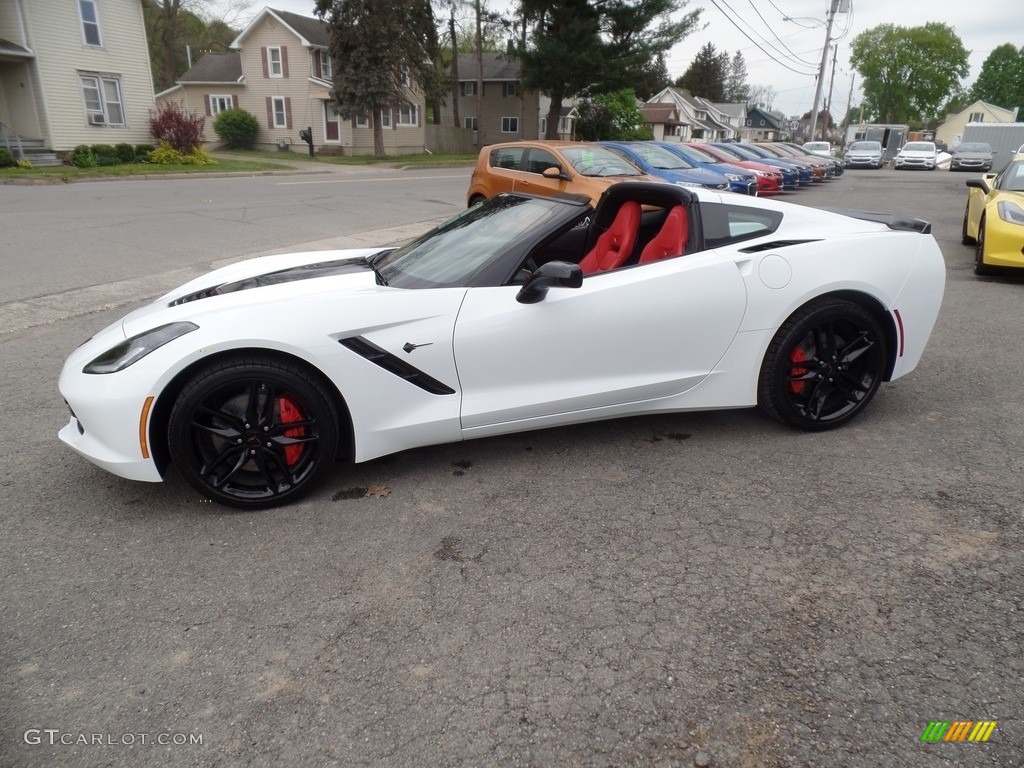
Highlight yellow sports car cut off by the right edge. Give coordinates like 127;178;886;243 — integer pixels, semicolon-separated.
964;155;1024;274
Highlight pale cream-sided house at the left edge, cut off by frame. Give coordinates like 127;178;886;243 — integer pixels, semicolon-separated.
0;0;154;160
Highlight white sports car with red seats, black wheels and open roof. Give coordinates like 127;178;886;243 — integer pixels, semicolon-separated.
59;182;945;508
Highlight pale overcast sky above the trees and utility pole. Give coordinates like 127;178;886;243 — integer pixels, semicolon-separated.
252;0;1024;115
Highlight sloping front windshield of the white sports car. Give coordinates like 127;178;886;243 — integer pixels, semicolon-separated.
371;195;565;288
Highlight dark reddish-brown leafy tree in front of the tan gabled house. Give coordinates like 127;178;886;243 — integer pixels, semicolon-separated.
315;0;436;158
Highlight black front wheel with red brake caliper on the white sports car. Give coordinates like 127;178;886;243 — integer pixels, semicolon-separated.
168;356;338;509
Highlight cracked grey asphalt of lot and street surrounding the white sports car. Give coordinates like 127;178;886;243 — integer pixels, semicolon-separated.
0;165;1024;768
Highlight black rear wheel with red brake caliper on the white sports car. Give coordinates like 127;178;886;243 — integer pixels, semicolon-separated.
758;299;889;432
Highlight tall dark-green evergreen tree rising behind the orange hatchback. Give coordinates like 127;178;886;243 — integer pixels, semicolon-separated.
519;0;699;138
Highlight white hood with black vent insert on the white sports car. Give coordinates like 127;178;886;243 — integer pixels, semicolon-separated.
121;248;387;337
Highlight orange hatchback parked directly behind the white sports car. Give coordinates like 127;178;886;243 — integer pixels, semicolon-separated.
466;141;660;206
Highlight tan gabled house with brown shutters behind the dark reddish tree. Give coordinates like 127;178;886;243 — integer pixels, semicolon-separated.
157;8;424;155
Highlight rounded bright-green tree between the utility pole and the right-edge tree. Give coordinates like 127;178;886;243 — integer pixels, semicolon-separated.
850;22;970;123
